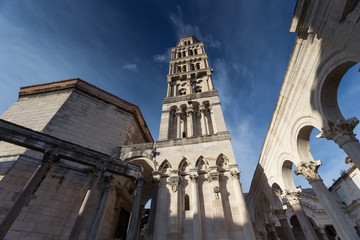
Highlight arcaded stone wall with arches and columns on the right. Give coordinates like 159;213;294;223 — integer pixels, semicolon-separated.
246;0;360;239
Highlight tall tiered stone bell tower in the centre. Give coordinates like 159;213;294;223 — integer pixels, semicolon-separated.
154;36;254;240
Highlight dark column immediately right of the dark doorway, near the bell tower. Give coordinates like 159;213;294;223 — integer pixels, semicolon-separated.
126;177;145;240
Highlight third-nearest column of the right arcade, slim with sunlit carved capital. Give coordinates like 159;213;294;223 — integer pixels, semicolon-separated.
283;191;318;240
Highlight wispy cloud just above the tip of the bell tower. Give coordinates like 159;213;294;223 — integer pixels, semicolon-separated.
170;6;221;48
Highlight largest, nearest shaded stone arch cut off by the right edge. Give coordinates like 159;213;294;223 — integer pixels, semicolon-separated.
312;52;360;122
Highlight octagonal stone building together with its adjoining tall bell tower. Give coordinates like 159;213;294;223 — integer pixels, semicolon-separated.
0;36;255;240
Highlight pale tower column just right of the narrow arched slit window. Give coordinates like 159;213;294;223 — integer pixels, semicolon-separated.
190;171;203;240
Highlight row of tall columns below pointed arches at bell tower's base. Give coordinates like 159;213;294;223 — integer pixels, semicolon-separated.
147;164;255;240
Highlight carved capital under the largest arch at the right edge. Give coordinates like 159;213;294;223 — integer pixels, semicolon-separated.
317;117;359;147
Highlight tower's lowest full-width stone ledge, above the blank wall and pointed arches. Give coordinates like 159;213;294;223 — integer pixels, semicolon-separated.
156;131;231;148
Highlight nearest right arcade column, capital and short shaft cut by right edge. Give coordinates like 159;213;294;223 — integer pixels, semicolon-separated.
317;117;360;169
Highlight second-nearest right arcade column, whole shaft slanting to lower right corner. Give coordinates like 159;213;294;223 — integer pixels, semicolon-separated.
295;160;360;239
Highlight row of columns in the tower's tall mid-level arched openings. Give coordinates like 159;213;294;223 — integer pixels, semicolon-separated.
168;101;217;139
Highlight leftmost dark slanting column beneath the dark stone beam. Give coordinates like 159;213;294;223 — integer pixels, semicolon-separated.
0;151;59;239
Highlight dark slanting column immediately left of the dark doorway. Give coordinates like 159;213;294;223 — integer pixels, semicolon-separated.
89;176;115;240
